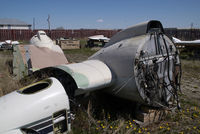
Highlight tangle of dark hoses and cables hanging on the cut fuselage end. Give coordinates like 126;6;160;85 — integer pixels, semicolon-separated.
137;32;181;109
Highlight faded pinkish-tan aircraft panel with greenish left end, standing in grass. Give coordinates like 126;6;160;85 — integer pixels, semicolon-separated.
13;45;68;79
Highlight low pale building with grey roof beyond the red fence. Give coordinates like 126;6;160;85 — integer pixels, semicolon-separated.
0;18;31;29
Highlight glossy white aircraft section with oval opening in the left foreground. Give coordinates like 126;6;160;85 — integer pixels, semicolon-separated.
0;77;71;133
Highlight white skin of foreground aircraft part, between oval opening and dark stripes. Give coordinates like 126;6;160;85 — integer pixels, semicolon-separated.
0;78;69;133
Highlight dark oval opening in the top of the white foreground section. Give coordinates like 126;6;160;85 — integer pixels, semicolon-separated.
17;79;52;94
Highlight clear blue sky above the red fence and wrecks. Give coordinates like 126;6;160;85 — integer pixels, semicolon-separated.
0;0;200;29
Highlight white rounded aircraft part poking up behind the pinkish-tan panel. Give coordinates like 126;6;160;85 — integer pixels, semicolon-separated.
30;31;63;53
